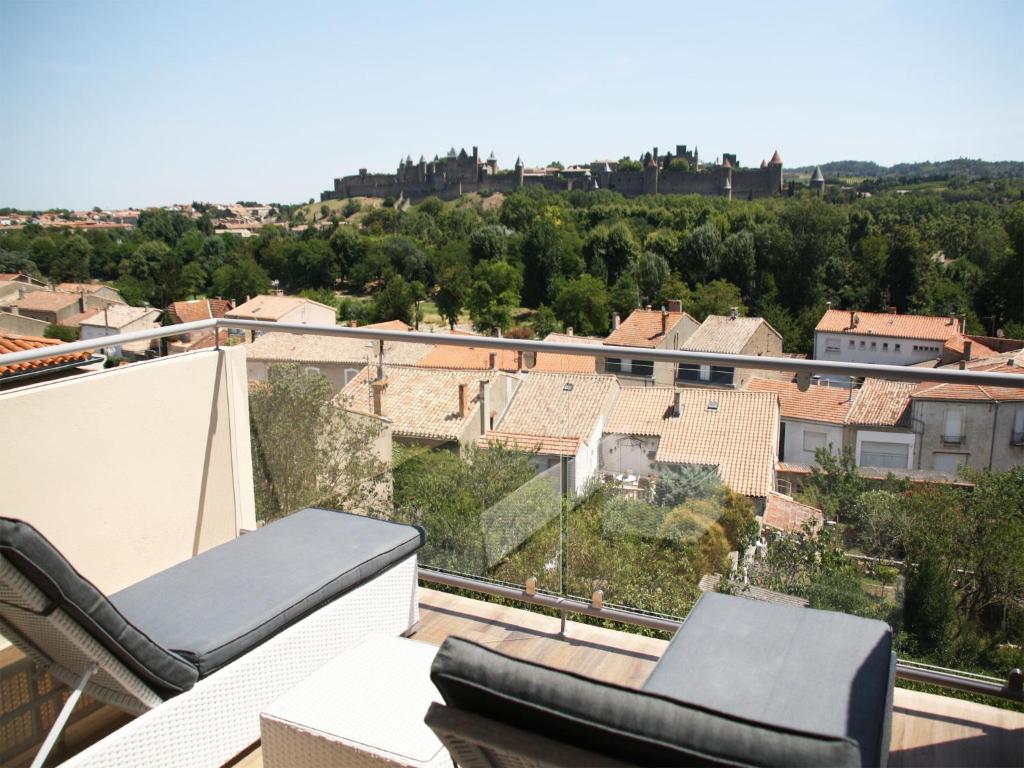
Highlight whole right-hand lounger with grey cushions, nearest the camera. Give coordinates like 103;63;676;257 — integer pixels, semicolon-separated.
426;593;895;768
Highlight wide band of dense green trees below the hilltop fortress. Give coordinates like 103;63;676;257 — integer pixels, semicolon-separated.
0;180;1024;351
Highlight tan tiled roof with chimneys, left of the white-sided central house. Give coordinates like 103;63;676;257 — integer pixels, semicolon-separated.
335;366;511;440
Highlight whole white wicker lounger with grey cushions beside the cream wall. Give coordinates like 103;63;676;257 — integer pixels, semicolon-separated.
0;509;424;766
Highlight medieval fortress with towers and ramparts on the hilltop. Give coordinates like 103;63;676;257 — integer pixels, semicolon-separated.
321;144;824;200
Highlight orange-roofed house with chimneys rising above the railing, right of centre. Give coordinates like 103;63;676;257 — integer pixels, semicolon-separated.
598;301;700;386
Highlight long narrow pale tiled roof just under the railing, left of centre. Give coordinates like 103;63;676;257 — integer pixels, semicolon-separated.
246;331;433;367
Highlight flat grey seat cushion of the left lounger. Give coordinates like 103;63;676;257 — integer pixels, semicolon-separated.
111;509;424;677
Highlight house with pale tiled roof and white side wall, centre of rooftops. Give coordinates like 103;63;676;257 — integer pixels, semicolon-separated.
476;372;620;493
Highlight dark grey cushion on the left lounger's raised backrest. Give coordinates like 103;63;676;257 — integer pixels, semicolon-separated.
0;517;199;697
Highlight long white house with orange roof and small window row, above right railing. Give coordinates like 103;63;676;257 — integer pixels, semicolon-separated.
814;309;965;366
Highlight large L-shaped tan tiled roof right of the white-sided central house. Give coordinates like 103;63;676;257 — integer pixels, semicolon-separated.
604;387;779;496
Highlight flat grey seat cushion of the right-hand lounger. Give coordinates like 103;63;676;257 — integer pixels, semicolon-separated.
643;592;893;765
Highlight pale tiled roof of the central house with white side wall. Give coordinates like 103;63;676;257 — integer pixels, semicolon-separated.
495;373;620;442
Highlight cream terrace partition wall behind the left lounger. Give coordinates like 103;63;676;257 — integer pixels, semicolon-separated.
0;347;256;593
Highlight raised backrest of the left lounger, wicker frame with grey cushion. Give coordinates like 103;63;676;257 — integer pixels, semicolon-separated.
0;517;199;712
